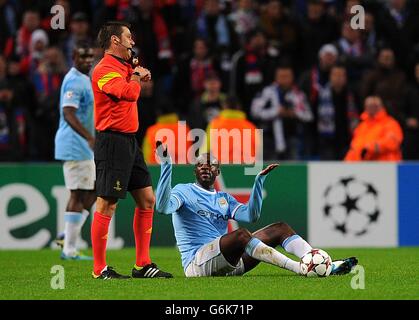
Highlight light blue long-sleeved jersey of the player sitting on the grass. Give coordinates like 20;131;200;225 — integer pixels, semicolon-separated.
156;163;265;269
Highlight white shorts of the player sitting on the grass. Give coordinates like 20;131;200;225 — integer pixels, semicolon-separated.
185;236;244;277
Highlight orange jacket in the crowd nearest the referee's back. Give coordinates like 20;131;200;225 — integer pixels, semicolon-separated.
143;113;193;164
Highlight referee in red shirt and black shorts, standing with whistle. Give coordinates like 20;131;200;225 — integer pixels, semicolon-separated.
91;22;172;279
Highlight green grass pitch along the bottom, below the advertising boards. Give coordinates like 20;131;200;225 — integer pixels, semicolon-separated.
0;247;419;300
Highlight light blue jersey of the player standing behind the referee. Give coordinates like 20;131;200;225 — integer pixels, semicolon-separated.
55;67;94;160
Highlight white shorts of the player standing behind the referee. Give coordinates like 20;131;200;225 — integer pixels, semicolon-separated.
63;160;96;190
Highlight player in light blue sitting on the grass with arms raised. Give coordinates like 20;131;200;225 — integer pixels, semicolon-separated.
156;142;358;277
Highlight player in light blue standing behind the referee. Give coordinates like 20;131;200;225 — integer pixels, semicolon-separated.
55;42;96;260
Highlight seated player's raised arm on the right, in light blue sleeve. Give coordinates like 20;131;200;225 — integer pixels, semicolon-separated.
231;163;279;222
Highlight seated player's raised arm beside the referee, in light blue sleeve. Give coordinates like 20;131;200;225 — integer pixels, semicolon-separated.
156;141;183;214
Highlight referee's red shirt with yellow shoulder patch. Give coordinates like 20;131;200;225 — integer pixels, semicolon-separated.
92;54;141;133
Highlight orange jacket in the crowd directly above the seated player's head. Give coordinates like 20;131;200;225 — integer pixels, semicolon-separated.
201;109;259;164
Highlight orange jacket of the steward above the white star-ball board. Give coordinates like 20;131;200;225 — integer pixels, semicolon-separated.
345;109;403;161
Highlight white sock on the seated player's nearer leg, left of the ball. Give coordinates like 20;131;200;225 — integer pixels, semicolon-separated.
246;238;300;274
